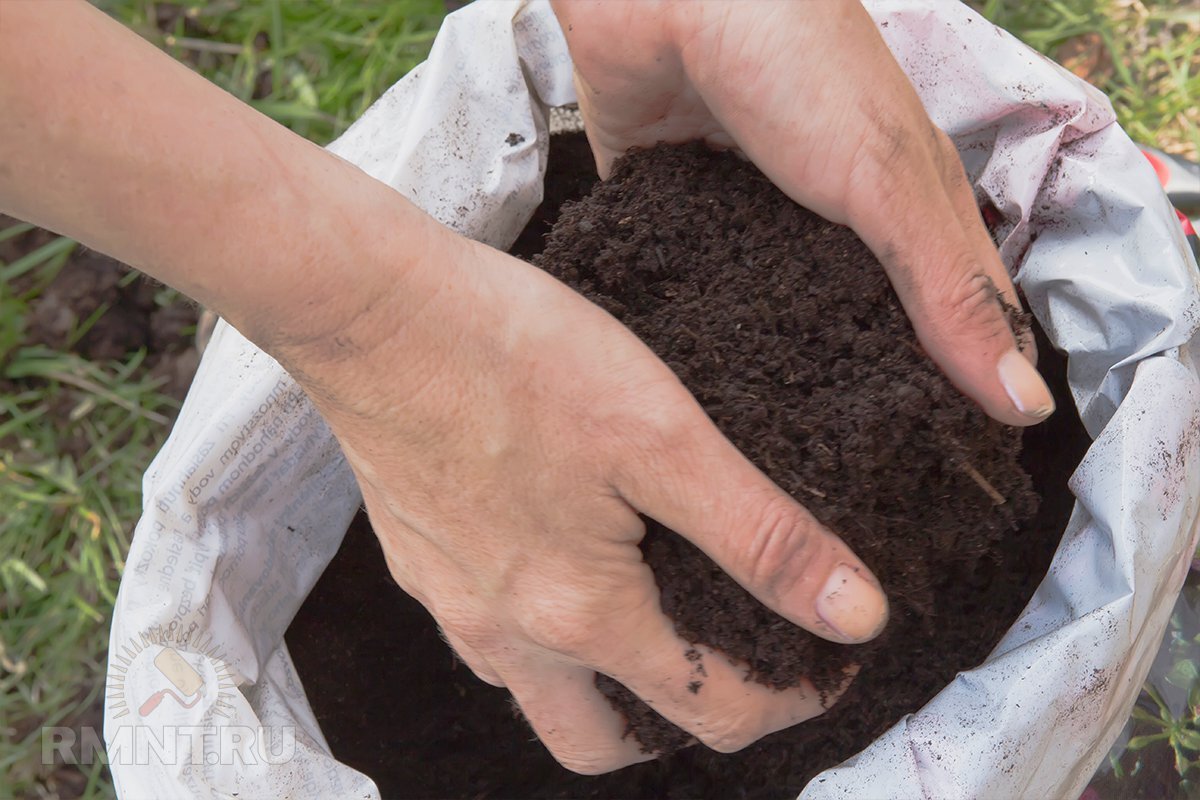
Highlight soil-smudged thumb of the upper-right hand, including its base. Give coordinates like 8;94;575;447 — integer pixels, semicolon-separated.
816;21;1055;425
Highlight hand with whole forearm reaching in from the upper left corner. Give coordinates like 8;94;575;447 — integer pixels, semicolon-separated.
0;4;887;772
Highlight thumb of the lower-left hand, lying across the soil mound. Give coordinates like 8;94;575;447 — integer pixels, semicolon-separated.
613;407;888;644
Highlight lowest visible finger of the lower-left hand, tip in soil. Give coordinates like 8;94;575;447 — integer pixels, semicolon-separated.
496;657;654;775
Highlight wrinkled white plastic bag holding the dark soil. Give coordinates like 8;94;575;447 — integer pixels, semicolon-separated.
106;0;1200;799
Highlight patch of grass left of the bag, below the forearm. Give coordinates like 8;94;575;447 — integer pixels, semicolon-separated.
0;347;173;794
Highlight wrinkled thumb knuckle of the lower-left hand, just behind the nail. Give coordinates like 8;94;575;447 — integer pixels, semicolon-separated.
739;497;818;597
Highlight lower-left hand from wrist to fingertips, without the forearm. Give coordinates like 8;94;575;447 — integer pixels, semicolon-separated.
278;221;887;774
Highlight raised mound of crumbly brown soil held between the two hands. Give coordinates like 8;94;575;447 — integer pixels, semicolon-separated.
534;144;1038;752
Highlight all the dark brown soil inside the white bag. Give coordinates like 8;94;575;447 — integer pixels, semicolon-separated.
288;136;1088;798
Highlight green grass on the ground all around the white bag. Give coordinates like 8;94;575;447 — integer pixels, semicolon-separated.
0;0;1200;798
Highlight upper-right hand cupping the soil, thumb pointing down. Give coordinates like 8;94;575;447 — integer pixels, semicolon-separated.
553;0;1054;425
